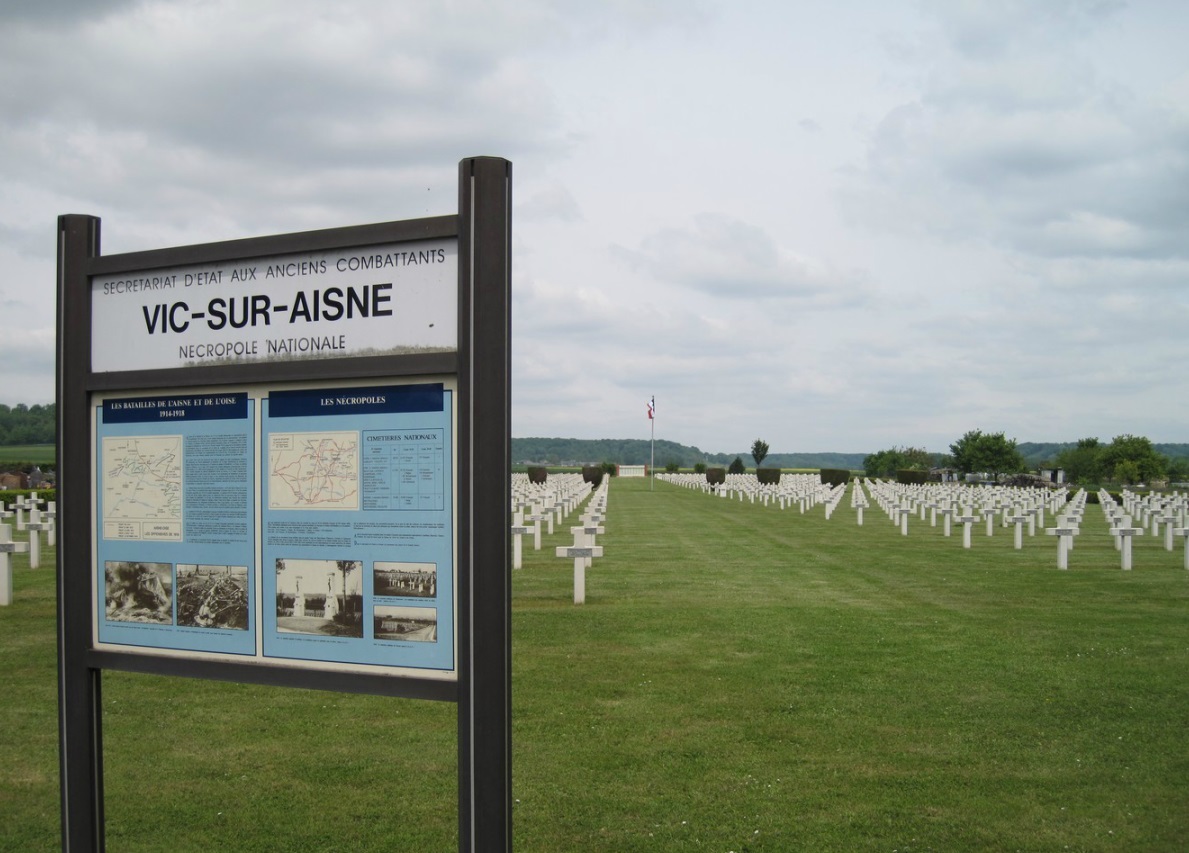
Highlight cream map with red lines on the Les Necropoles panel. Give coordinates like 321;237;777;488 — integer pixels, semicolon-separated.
269;432;359;509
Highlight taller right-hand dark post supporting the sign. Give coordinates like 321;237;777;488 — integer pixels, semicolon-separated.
458;157;512;853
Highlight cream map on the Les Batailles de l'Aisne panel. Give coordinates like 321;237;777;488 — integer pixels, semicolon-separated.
103;435;182;523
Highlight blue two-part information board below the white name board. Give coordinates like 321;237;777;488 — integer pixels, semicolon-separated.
95;382;458;677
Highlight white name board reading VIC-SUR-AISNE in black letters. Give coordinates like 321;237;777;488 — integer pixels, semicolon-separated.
90;239;458;372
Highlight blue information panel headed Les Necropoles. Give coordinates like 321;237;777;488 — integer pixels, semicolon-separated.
260;383;454;671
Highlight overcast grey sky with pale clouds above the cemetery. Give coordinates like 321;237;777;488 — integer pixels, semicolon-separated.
0;0;1189;453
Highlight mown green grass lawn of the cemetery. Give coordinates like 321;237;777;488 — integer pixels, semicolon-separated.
0;479;1189;853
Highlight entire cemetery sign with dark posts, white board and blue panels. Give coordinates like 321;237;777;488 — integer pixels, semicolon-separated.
57;157;511;853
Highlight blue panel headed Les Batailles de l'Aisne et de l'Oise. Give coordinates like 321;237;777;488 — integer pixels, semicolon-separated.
95;393;258;654
